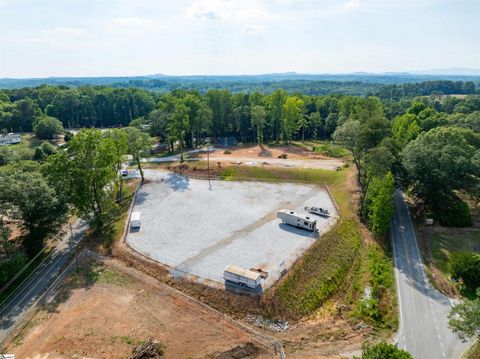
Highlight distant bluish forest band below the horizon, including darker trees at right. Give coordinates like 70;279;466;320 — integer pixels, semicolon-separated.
0;73;480;98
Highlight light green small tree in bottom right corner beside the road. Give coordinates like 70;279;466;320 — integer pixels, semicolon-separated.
448;288;480;340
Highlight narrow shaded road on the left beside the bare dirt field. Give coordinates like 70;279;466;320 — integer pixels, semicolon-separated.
0;220;87;343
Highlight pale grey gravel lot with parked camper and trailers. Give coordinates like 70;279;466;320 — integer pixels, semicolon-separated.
127;170;337;288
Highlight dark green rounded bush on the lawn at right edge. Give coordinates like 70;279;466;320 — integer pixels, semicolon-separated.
450;252;480;290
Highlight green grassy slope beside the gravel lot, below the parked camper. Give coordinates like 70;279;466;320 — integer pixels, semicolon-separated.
267;220;361;319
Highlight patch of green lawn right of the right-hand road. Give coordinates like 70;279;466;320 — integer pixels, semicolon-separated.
430;229;480;277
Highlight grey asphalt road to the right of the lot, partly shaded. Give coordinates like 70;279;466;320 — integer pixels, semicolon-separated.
392;190;468;359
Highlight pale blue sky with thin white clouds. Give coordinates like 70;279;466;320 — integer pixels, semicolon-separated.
0;0;480;78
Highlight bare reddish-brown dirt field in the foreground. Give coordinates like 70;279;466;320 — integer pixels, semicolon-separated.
7;255;273;358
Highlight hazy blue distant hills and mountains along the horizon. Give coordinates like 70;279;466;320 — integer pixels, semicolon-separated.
0;68;480;94
